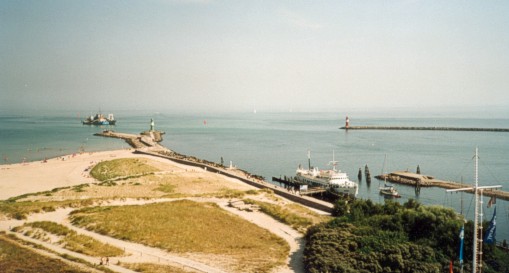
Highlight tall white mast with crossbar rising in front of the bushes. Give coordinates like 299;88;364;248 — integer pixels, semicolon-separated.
446;147;502;273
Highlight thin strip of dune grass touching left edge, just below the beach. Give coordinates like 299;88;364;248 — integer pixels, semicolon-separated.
0;199;94;220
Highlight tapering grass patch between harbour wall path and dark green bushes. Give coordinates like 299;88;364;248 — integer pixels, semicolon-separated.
244;199;331;232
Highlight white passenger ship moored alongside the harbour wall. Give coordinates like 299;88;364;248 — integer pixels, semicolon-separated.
295;152;359;197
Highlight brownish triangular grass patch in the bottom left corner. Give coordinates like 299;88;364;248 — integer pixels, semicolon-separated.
0;232;88;273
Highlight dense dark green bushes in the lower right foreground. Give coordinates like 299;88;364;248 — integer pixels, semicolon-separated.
304;200;509;272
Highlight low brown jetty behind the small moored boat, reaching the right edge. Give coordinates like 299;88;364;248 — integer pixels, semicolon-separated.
375;171;509;201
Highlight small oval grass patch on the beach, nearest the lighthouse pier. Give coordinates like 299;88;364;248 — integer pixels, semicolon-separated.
90;158;159;182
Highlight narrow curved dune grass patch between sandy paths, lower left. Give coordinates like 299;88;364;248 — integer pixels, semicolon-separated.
13;221;124;257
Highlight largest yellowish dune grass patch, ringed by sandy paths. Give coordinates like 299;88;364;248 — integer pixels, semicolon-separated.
71;200;289;272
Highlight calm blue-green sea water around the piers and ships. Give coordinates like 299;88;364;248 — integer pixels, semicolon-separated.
0;112;509;241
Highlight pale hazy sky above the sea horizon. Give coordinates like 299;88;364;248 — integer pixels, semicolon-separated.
0;0;509;112
